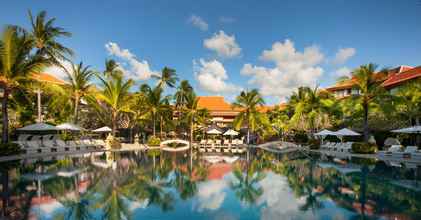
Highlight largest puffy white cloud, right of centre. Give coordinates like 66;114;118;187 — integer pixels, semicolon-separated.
241;39;324;99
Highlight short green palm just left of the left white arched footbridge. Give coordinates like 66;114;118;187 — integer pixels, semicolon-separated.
140;84;171;136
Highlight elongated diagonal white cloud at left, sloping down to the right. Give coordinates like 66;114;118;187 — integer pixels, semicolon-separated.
105;42;158;80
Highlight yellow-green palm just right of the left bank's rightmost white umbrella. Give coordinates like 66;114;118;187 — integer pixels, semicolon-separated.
97;75;134;135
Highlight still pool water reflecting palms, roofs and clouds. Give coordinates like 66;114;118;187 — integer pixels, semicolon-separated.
1;152;421;220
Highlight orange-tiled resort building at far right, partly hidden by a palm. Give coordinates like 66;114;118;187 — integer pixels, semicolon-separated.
326;66;421;98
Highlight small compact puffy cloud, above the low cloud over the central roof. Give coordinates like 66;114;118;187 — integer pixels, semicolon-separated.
203;31;241;58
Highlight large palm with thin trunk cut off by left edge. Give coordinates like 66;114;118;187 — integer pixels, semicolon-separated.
0;26;48;143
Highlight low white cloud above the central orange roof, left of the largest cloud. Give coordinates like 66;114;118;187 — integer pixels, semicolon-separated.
193;59;241;94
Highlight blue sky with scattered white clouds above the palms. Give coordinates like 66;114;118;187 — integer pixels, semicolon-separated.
0;0;421;103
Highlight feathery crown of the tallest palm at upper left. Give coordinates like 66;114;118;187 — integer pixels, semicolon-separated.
29;11;73;62
